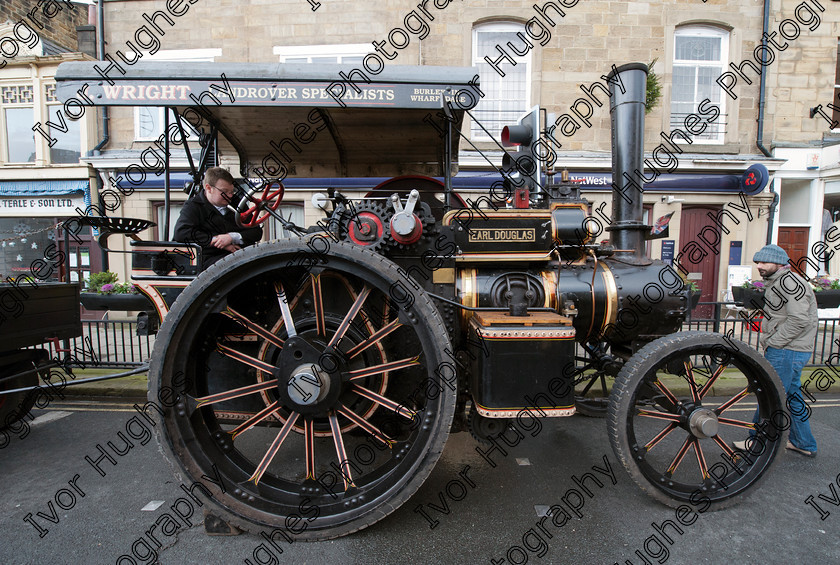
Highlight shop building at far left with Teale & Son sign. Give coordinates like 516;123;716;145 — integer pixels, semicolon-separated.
0;0;97;281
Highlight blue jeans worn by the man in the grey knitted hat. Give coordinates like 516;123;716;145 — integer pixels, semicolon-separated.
750;347;817;452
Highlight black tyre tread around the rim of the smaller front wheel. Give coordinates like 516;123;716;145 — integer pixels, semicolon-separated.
607;331;787;511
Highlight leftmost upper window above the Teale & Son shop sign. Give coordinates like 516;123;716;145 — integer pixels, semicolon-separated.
0;84;35;163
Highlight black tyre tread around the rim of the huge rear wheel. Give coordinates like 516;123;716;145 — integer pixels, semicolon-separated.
148;234;455;541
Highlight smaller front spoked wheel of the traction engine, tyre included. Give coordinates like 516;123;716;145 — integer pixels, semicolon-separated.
607;332;790;509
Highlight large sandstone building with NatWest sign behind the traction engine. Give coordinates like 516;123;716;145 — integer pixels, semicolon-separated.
70;0;840;306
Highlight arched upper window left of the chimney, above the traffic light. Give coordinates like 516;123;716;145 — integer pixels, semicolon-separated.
470;23;531;141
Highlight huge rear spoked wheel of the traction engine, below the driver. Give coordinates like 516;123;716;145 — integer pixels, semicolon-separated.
150;236;457;539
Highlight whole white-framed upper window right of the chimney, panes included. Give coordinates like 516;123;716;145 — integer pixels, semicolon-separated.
671;26;729;143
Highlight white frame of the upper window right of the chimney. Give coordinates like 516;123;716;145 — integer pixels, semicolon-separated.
668;24;732;145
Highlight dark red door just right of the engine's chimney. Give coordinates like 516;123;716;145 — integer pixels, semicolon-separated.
680;206;721;318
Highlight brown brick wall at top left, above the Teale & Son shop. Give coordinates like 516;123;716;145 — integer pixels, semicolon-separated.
0;0;88;52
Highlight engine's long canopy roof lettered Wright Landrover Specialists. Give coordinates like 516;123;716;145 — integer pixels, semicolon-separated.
56;62;479;177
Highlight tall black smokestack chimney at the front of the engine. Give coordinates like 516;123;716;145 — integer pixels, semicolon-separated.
607;63;651;265
